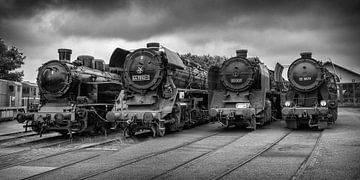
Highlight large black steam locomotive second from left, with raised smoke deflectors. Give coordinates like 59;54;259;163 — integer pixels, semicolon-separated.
106;43;208;137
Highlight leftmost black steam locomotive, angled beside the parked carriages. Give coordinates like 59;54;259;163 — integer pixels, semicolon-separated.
17;49;122;136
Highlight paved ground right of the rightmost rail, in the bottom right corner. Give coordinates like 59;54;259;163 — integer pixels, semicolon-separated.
300;108;360;180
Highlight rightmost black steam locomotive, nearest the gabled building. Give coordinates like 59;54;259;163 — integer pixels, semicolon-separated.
276;52;338;129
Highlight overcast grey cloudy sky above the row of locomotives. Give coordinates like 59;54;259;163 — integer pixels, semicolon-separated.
0;0;360;81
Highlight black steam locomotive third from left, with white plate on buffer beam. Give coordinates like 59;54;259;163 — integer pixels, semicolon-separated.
208;50;281;130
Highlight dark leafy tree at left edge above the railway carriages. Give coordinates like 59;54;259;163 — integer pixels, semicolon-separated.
0;38;26;82
